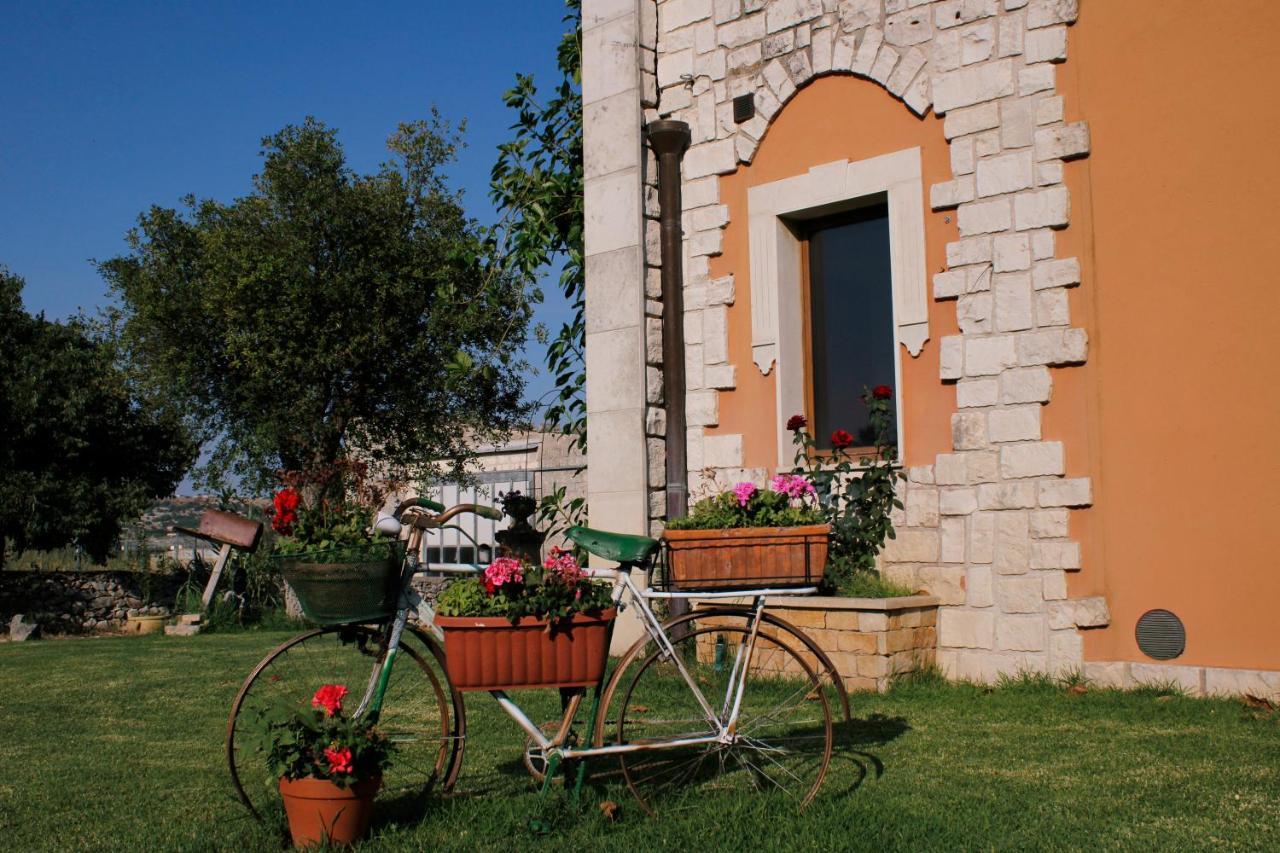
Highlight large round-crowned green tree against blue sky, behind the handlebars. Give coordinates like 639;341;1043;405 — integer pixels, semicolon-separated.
99;114;530;489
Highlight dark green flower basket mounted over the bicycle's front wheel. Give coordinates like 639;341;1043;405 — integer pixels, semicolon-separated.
275;542;404;625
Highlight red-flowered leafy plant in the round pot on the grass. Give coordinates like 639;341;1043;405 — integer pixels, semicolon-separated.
246;684;393;788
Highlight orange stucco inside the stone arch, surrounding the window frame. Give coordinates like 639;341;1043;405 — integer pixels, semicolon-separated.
709;77;959;470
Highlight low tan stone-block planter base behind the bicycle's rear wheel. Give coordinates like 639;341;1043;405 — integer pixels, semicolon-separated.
694;596;938;693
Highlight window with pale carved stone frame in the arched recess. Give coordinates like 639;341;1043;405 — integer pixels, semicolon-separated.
746;149;929;467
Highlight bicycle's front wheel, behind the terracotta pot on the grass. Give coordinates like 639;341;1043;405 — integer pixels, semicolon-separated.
227;625;465;818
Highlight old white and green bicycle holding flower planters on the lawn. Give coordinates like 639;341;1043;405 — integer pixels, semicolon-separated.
227;498;849;818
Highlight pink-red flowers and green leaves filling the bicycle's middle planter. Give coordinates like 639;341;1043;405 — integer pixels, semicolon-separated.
435;548;613;622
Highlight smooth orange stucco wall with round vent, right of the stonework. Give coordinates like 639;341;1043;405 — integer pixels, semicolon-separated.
1044;0;1280;670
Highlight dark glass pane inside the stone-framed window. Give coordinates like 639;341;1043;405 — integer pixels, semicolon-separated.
809;202;896;447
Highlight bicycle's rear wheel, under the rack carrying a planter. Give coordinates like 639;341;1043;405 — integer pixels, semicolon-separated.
607;625;832;813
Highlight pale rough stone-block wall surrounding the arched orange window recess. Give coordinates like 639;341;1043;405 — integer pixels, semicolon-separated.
627;0;1108;680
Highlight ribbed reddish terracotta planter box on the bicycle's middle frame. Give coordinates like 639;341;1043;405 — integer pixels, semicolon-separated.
435;607;617;690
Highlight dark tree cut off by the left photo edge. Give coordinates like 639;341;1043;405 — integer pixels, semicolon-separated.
0;268;195;566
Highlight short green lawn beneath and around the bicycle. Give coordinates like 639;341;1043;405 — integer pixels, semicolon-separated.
0;633;1280;853
